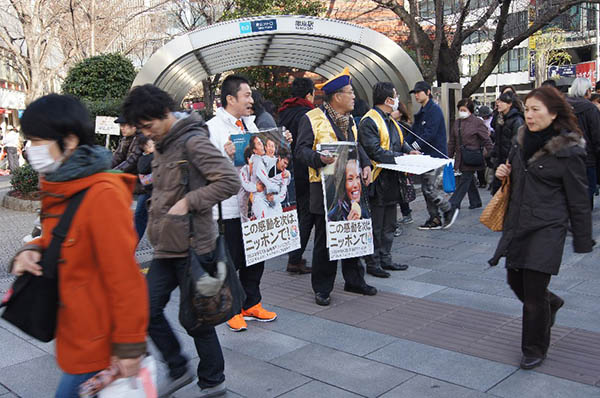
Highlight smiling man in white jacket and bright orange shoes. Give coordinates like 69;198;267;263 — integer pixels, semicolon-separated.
207;75;277;332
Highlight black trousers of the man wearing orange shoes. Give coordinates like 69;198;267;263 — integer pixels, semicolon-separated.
224;218;265;310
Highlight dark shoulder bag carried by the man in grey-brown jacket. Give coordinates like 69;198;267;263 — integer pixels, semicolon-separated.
179;136;246;335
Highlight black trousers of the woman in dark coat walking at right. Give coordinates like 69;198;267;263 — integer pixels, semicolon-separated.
507;269;561;358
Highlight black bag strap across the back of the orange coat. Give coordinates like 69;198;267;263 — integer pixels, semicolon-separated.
42;188;87;279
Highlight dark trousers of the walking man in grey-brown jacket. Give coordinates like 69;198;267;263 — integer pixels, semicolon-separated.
146;257;225;388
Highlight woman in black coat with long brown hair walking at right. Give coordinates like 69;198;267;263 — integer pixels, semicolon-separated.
490;87;593;369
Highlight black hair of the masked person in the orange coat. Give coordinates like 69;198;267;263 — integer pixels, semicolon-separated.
21;94;95;151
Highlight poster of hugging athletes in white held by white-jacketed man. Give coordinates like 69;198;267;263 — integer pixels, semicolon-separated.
231;128;300;265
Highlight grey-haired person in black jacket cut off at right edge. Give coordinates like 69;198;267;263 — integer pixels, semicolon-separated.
567;77;600;209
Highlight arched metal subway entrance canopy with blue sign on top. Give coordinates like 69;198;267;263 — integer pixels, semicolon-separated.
133;16;423;103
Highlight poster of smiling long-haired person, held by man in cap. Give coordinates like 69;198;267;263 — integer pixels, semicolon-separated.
318;142;373;260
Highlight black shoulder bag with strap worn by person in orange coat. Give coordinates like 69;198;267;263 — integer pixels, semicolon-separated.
0;189;87;343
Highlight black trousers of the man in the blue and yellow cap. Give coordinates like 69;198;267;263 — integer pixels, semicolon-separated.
311;214;366;294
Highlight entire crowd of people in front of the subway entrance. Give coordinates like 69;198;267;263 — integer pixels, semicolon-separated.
6;69;600;397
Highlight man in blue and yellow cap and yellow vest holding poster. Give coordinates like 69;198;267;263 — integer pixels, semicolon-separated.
295;68;377;306
